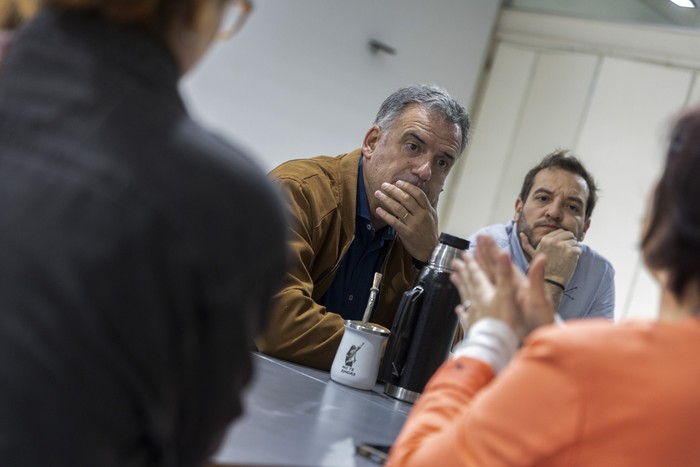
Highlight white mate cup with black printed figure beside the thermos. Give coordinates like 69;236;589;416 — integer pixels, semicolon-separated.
331;320;390;389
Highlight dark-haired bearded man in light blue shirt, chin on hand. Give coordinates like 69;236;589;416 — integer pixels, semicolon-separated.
466;149;615;320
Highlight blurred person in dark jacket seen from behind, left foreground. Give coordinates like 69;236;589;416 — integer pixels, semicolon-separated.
0;0;287;467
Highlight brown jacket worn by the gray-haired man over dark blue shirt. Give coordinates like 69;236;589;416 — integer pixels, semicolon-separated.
257;149;418;370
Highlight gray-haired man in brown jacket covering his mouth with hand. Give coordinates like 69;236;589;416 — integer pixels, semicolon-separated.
257;85;469;370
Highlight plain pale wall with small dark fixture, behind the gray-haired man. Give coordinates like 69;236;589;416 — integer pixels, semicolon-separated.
183;0;500;169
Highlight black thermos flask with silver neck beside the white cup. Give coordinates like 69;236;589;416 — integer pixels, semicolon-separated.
379;232;469;402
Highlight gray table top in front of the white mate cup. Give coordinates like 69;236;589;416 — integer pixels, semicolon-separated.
212;353;412;467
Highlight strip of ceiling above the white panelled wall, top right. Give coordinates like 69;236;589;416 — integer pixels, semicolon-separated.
503;0;700;29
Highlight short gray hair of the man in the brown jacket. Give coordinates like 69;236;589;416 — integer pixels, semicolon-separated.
374;84;469;154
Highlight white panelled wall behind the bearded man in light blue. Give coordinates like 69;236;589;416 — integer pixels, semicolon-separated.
441;11;700;319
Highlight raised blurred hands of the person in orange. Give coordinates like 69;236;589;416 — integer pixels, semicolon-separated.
450;235;554;342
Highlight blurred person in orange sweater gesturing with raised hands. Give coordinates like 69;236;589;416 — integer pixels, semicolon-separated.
388;104;700;467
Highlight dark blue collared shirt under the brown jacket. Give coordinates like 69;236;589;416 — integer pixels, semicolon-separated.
319;158;396;319
